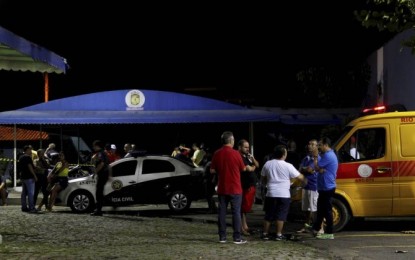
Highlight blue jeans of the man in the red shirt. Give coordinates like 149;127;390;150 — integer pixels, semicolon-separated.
218;194;242;240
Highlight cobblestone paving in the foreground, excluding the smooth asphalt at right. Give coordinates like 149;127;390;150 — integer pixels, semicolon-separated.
0;190;334;260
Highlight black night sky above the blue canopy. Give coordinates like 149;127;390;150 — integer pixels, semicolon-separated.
0;0;394;111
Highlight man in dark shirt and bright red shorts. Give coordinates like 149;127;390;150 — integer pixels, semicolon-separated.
238;139;259;236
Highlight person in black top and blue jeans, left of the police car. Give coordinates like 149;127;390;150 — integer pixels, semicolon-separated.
19;145;37;213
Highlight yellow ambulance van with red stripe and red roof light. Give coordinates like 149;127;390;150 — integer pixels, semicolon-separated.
333;105;415;232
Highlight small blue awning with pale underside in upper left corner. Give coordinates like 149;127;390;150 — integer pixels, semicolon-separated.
0;27;68;73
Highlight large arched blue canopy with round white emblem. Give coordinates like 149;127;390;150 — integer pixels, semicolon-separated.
0;89;279;124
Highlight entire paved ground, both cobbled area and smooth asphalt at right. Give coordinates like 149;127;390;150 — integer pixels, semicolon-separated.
6;190;415;260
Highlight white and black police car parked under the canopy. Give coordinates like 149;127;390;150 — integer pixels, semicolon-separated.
55;155;204;213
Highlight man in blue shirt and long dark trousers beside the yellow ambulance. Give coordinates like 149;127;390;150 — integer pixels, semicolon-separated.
313;137;339;239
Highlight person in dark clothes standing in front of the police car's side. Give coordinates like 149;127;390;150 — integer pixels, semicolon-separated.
91;140;110;216
